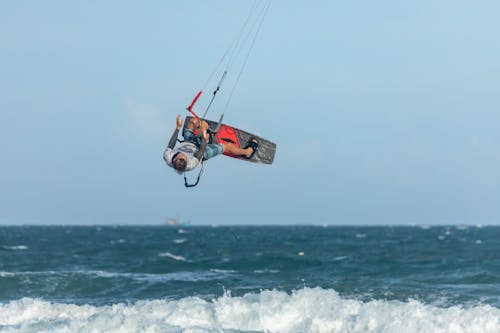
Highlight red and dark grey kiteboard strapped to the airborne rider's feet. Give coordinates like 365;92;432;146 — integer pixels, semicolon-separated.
184;116;276;164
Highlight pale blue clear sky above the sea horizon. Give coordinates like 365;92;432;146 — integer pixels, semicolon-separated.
0;0;500;225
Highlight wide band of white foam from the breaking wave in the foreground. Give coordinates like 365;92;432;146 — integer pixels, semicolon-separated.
0;288;500;333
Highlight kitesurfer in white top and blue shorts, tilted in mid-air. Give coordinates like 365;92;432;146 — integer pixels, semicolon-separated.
163;115;259;174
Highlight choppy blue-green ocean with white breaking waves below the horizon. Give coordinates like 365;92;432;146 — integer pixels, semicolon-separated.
0;225;500;333
